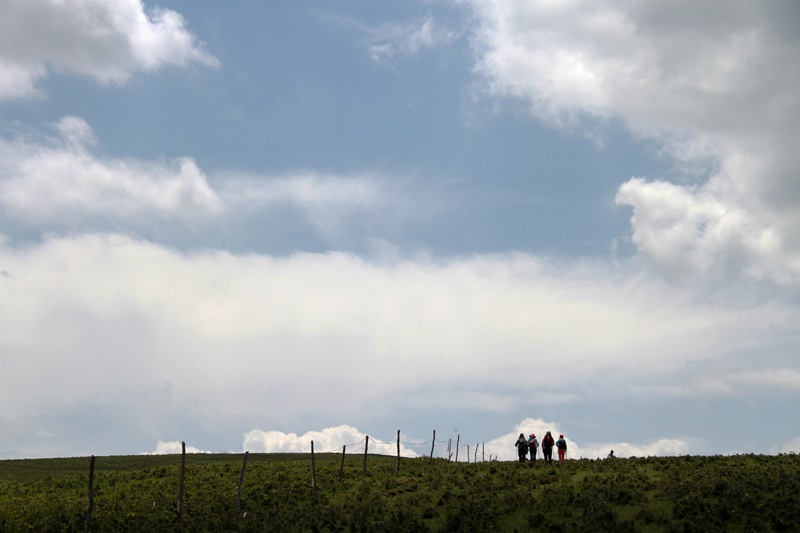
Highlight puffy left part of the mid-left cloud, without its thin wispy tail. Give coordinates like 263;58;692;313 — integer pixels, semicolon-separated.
0;116;223;222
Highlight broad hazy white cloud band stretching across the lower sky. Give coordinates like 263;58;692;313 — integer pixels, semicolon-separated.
0;235;795;442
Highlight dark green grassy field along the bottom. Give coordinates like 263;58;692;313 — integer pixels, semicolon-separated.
0;454;800;532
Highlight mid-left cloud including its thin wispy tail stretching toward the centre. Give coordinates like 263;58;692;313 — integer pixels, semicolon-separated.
0;116;432;245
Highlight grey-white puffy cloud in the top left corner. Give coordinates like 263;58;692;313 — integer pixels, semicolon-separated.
0;0;219;100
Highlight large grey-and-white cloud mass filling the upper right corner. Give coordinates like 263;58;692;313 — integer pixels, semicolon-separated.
467;0;800;287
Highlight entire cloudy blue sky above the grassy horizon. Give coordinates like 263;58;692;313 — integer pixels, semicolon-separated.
0;0;800;460
